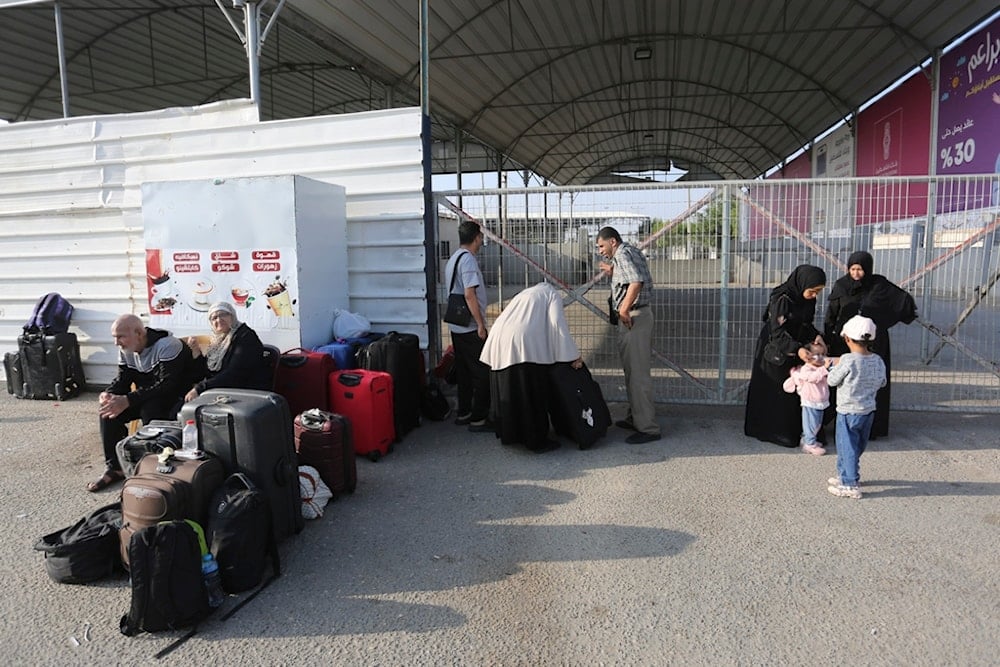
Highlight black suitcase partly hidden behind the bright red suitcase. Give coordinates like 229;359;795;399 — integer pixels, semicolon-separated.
357;331;423;440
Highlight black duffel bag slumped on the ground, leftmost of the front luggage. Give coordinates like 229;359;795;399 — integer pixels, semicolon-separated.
35;502;122;584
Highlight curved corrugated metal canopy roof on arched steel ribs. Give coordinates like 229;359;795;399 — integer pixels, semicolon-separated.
0;0;997;184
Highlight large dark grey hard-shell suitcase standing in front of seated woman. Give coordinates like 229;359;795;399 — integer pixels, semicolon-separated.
180;389;305;541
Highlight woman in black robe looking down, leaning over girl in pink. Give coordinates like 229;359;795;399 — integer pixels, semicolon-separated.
743;264;826;447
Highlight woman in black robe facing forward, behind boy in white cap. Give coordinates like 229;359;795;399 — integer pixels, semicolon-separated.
824;251;917;439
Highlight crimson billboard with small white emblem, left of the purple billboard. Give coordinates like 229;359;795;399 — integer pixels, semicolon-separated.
856;72;931;225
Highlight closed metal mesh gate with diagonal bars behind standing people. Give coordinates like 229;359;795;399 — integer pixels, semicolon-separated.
436;176;1000;412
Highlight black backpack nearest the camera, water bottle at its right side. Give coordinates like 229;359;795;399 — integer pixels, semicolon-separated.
120;520;211;637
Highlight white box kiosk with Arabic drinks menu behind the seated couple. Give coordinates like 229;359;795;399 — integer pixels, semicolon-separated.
142;176;349;351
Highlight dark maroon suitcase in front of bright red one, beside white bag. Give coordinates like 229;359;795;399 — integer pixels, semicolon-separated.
295;409;358;498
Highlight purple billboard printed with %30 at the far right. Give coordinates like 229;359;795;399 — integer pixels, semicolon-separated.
936;21;1000;211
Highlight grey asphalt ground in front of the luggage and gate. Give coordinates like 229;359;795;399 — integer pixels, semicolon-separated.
0;394;1000;667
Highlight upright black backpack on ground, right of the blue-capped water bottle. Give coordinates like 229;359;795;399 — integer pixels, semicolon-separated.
206;473;281;593
